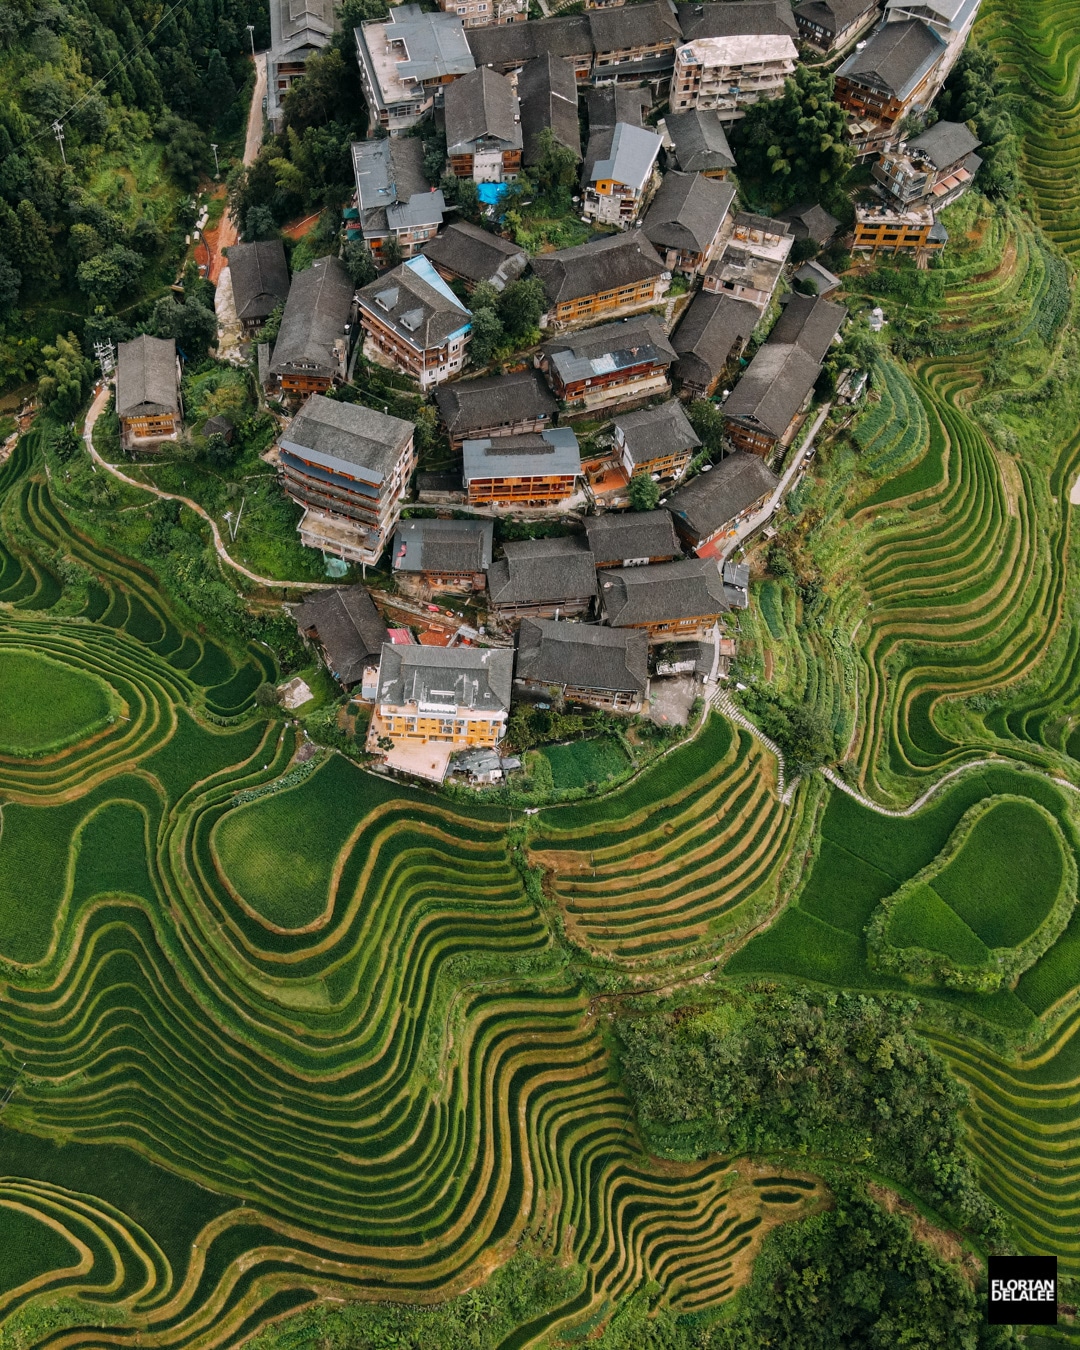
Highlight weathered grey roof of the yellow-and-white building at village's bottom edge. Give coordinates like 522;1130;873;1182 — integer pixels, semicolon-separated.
378;643;514;714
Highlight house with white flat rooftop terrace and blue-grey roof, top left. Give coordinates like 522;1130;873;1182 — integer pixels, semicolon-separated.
354;4;477;131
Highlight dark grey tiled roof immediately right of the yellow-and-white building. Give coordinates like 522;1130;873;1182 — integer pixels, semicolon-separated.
517;618;649;695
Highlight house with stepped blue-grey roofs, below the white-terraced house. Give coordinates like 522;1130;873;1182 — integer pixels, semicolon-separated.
346;136;447;267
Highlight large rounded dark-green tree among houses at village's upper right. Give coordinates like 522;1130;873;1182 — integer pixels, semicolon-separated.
732;66;855;207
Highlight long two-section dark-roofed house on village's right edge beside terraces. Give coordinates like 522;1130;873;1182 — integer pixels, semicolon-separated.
724;294;846;456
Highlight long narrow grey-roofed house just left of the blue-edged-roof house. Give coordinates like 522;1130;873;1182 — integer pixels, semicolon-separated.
269;257;352;398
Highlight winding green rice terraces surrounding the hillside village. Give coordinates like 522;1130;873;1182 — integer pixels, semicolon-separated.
8;0;1080;1350
